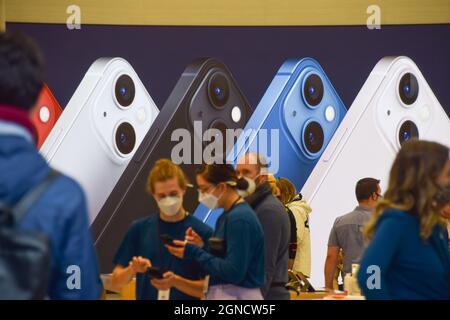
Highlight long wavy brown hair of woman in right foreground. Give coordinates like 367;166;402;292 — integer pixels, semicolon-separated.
365;140;449;240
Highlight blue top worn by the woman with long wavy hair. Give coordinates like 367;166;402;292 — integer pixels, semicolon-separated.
358;209;450;300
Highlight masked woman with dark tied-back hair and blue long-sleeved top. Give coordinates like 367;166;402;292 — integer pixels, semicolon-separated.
167;164;264;300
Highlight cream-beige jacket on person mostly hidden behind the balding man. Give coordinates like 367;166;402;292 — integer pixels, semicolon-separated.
287;199;312;277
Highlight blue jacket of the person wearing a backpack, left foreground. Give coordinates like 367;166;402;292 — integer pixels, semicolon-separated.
0;121;101;299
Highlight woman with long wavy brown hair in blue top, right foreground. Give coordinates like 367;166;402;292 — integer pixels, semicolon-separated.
358;140;450;300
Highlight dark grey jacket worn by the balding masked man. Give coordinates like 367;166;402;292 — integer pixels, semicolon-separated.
245;182;290;300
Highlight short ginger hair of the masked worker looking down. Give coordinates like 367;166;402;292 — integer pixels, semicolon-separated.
146;159;189;194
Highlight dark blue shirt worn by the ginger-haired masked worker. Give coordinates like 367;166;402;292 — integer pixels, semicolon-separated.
113;214;212;300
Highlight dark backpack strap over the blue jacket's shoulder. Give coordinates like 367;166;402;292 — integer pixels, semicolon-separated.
11;169;59;224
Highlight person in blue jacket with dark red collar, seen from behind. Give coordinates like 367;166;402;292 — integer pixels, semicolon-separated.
0;33;102;299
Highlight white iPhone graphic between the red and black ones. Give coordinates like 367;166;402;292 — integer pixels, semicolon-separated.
40;58;159;223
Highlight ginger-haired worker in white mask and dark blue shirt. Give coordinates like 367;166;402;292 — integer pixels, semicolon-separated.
112;159;212;300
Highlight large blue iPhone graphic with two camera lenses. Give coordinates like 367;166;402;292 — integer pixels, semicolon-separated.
194;58;347;227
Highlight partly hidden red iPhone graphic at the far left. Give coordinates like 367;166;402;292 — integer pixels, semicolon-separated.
31;83;62;149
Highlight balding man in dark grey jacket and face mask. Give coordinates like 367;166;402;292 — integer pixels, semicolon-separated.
236;153;291;300
